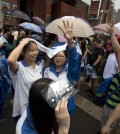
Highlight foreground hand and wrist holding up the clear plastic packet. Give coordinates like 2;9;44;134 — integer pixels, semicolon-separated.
55;99;70;134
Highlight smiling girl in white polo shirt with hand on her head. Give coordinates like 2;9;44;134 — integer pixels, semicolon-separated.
8;38;43;122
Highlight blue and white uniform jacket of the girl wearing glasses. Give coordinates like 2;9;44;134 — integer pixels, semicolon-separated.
44;43;81;113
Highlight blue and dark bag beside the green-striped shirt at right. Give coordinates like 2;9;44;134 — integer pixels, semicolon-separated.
94;77;113;106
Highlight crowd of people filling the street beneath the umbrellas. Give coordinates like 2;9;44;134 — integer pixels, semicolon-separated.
0;21;120;134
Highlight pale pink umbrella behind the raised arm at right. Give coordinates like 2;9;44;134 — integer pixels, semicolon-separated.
93;24;120;35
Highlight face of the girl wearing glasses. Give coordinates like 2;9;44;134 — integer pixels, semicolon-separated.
54;51;67;66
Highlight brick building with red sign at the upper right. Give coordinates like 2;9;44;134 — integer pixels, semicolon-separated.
88;0;114;26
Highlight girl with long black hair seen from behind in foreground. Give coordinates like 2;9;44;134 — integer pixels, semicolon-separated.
16;78;70;134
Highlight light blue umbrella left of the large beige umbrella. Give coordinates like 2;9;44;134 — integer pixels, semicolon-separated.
19;22;43;33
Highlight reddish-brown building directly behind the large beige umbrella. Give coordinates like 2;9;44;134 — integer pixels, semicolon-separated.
20;0;89;23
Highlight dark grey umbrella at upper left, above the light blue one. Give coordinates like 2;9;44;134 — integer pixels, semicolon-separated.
10;9;31;21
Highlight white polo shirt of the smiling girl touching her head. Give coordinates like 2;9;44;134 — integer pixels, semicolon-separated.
10;60;43;117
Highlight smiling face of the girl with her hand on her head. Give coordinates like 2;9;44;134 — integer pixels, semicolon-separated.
23;43;39;62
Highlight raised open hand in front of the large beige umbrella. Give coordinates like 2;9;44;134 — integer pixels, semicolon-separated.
58;21;74;48
